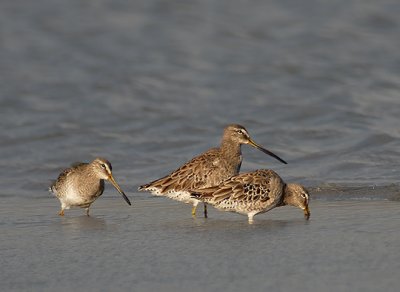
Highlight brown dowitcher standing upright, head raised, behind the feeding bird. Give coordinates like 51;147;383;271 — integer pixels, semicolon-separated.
139;124;286;217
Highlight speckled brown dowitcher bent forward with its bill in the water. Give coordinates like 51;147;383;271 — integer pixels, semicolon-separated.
192;169;310;223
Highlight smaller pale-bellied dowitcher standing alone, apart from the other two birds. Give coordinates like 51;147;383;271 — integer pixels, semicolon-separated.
49;158;131;216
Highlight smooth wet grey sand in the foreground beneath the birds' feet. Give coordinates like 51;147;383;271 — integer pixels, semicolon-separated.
0;195;400;291
